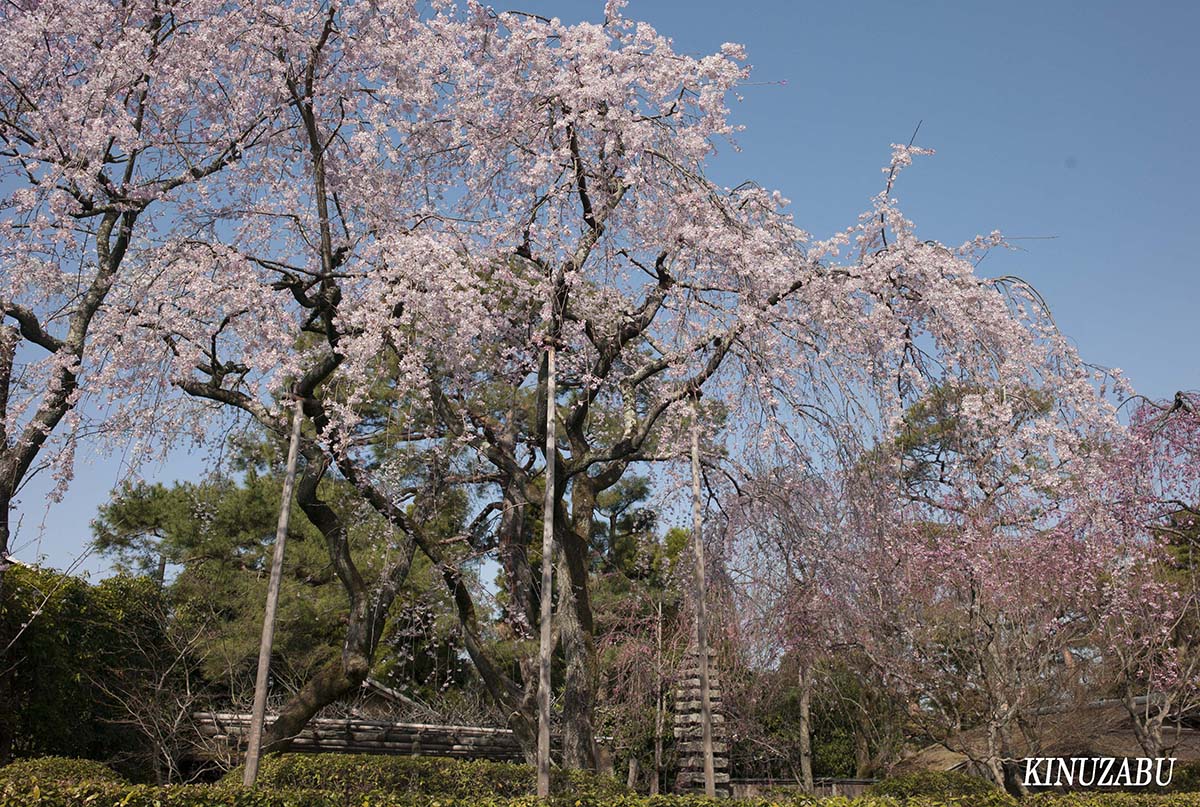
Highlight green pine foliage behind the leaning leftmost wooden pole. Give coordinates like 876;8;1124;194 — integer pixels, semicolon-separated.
92;475;346;681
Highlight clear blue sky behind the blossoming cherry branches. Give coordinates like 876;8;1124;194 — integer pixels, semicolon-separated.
16;0;1200;573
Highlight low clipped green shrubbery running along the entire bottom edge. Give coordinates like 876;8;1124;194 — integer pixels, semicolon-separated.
0;754;1200;807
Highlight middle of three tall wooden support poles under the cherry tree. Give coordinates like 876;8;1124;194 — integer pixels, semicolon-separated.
538;345;557;799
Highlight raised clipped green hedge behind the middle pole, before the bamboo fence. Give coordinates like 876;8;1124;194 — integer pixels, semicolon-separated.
223;754;629;799
